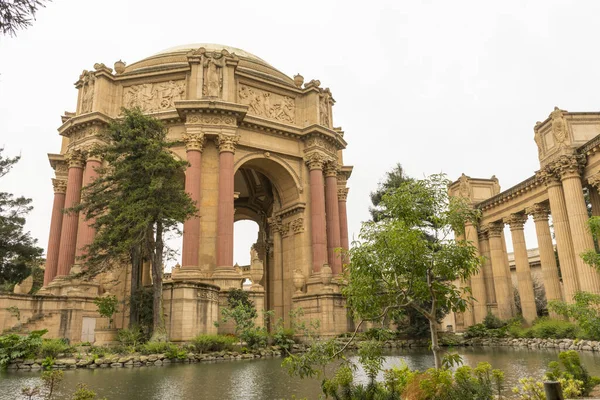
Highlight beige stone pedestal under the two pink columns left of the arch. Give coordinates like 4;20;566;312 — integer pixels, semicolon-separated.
163;282;219;342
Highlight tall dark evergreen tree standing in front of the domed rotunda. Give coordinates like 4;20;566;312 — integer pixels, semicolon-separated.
71;109;197;341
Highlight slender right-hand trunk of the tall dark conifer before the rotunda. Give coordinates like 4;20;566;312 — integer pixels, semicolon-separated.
150;221;168;342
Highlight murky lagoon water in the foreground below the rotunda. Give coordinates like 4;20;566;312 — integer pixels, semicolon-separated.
0;347;600;400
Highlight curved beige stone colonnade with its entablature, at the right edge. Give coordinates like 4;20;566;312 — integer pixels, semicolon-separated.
443;107;600;330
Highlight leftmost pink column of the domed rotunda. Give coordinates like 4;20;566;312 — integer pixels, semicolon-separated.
44;179;67;286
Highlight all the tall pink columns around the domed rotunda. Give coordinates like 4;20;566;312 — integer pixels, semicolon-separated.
44;134;348;286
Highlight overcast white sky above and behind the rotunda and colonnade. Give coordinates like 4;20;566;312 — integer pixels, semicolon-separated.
0;0;600;264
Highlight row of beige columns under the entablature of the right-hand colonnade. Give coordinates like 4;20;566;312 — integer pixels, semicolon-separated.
464;155;600;326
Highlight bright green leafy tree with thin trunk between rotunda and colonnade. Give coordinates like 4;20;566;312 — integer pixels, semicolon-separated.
344;175;480;368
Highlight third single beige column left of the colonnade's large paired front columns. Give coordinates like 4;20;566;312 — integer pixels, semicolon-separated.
488;222;515;319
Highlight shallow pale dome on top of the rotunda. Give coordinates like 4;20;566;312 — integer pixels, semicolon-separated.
125;43;294;86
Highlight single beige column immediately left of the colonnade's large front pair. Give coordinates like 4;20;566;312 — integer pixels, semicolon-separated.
525;204;562;312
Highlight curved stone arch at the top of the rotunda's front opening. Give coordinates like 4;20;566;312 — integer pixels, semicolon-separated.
234;152;302;206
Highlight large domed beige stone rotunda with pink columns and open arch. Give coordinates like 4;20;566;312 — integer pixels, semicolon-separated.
4;44;352;341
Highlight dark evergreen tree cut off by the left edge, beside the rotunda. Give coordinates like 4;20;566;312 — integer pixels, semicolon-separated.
0;148;42;286
